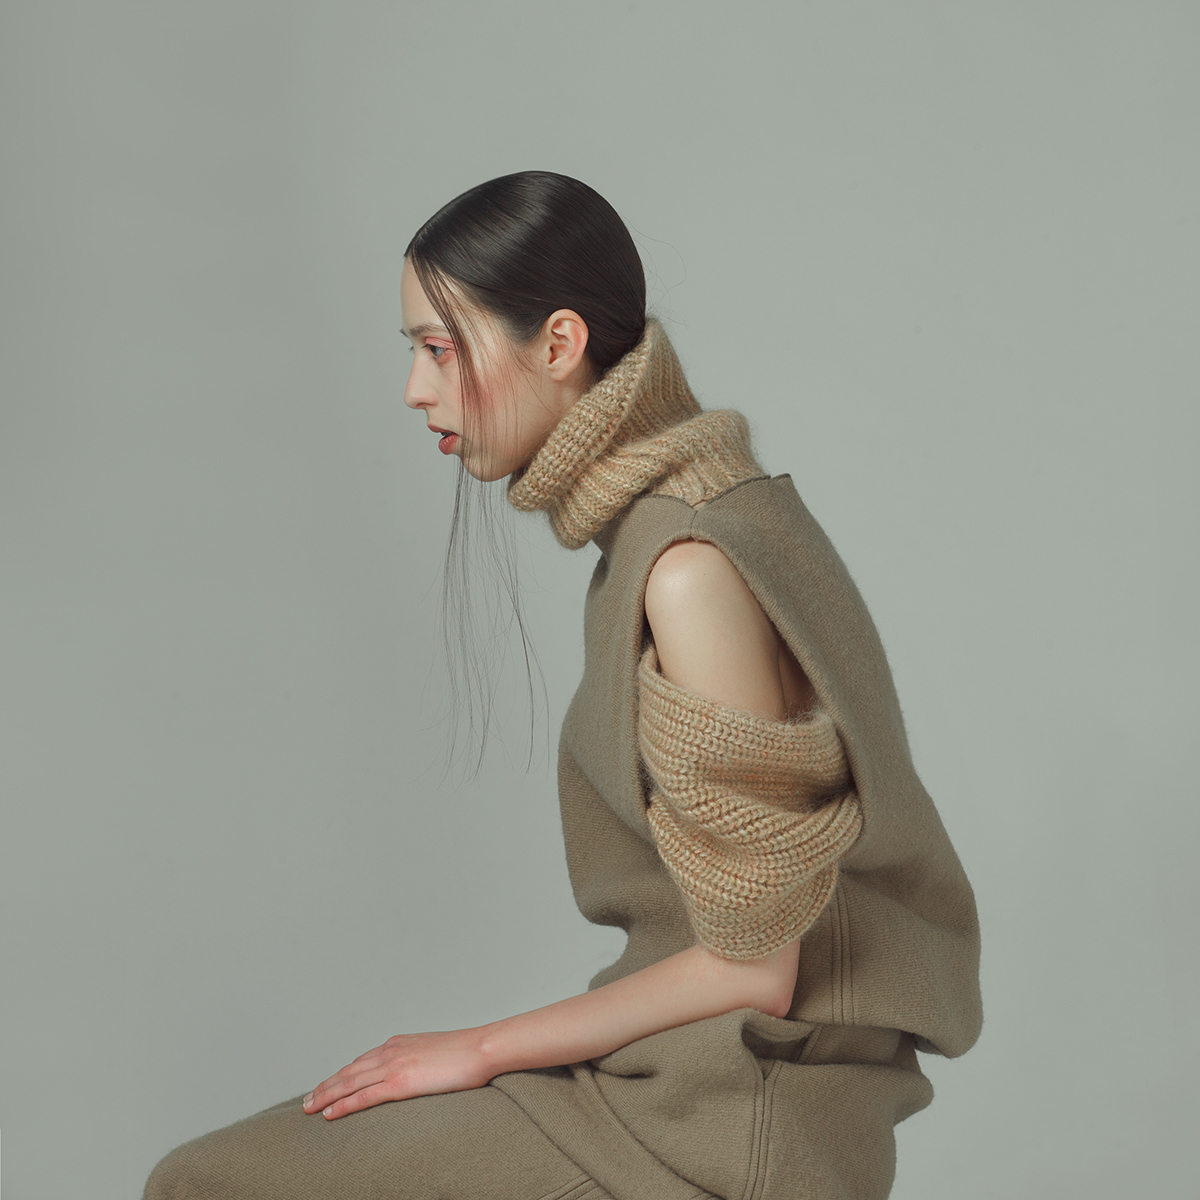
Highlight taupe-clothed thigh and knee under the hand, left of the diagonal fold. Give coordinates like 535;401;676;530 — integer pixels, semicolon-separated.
144;1087;606;1200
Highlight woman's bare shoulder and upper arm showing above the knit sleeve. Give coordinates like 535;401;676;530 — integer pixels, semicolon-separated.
644;541;786;720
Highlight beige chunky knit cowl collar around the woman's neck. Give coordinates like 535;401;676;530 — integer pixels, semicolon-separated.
509;318;764;550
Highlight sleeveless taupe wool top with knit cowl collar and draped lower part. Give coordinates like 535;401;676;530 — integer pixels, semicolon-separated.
493;320;982;1200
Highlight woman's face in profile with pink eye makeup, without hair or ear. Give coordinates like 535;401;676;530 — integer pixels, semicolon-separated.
400;259;578;482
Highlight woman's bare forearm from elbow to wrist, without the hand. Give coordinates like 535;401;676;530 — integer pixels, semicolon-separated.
476;941;799;1075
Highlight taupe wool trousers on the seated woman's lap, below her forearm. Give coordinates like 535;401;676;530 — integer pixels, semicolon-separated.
144;1010;932;1200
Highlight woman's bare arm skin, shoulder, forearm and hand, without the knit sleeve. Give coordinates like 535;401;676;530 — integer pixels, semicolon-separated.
304;541;806;1120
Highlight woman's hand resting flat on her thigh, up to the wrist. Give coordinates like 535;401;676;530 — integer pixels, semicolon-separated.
304;1030;494;1121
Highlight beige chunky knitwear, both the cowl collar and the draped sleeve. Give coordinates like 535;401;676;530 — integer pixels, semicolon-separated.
509;320;862;959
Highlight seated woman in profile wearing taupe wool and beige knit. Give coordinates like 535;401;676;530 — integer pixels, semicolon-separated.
146;172;980;1200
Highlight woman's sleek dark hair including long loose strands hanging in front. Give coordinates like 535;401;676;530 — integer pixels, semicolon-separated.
404;170;646;772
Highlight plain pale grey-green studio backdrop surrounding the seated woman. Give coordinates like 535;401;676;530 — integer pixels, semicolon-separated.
0;0;1200;1200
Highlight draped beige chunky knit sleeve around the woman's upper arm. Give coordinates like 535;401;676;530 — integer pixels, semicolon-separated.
638;643;862;959
